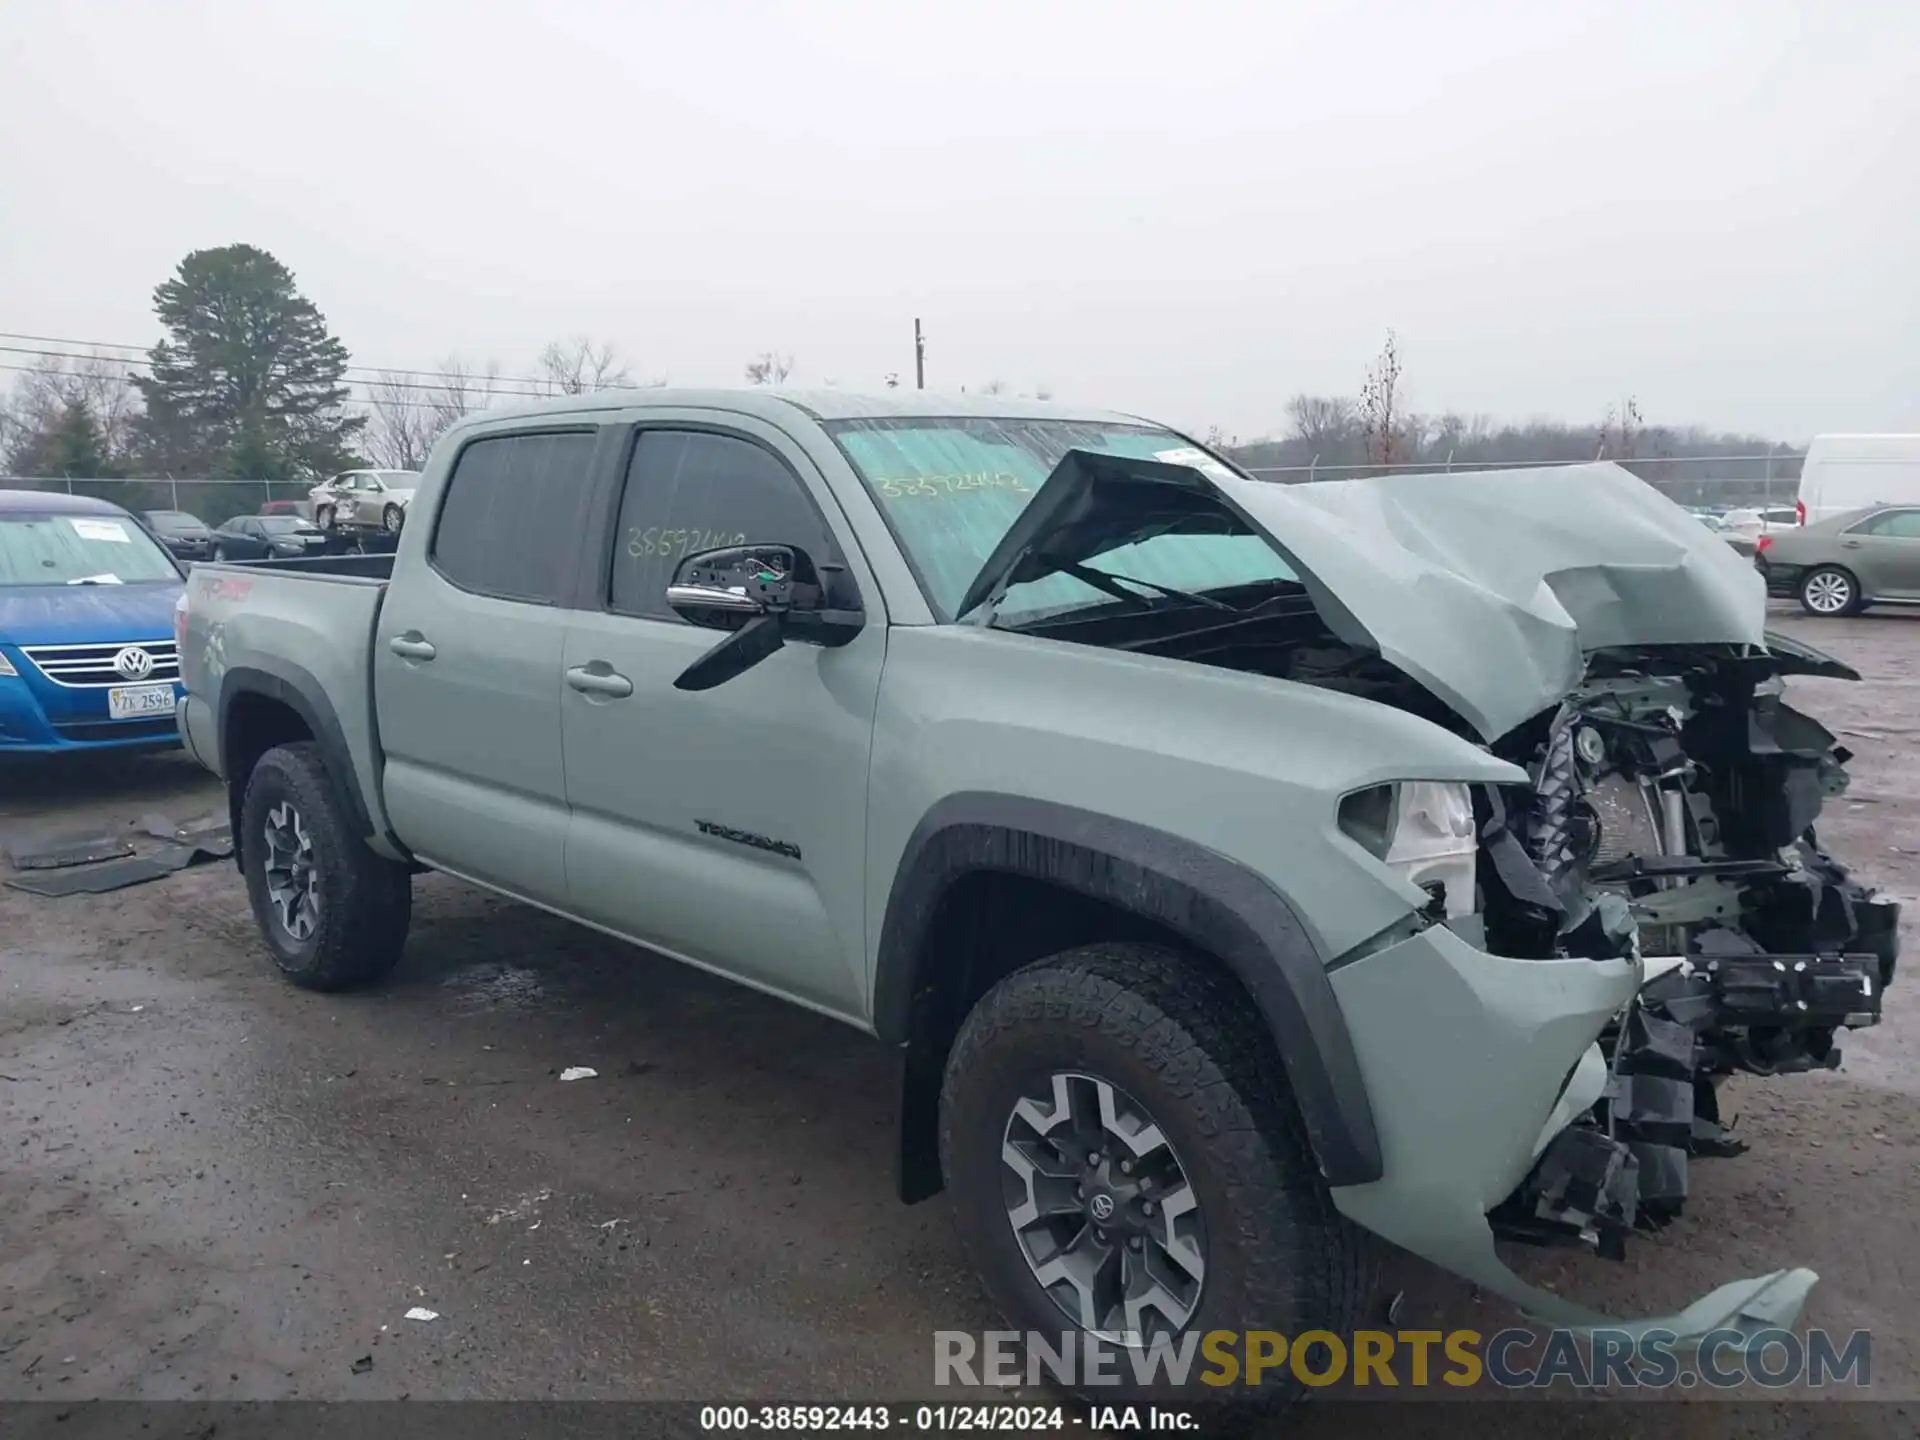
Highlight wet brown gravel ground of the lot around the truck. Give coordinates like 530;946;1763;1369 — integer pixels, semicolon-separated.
0;611;1920;1432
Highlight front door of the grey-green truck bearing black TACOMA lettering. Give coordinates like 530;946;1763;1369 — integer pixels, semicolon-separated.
561;417;887;1020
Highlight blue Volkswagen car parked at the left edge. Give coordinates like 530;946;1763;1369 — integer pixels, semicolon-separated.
0;490;184;755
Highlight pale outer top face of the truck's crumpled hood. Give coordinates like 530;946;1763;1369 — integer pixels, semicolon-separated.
1244;463;1766;739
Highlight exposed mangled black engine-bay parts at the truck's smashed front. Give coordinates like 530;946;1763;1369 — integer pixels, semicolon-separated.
1480;645;1899;1258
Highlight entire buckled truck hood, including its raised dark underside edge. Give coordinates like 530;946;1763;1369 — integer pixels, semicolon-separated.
960;449;1766;739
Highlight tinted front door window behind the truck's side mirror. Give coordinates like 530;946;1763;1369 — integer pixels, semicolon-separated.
607;430;837;624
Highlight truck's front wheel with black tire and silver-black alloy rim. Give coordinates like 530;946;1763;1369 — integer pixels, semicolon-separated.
941;945;1371;1404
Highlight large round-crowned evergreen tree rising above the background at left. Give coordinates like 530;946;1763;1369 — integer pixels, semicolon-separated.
134;246;367;480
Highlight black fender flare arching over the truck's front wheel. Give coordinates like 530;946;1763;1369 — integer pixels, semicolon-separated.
874;791;1384;1185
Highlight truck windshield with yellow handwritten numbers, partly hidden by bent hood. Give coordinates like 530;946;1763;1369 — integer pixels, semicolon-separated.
826;417;1298;622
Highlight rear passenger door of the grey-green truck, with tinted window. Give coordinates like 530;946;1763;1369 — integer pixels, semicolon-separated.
372;428;597;906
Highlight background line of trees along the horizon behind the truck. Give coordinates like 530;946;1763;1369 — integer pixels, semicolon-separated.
0;246;1797;503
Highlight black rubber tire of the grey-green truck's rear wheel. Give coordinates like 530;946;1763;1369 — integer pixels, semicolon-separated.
236;741;413;991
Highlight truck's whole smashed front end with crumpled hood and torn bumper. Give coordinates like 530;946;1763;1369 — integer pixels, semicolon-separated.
958;449;1899;1344
